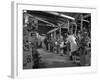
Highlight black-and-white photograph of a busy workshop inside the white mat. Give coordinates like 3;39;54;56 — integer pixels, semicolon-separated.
23;10;91;69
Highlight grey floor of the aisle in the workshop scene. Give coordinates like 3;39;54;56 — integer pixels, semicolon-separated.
24;49;79;69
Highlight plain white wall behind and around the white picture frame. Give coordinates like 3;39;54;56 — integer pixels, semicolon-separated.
0;0;100;80
